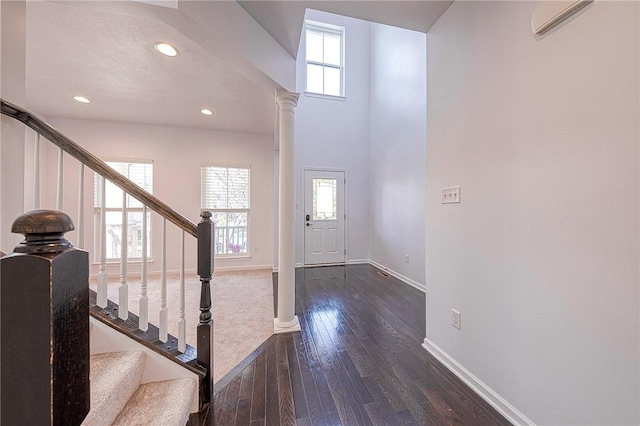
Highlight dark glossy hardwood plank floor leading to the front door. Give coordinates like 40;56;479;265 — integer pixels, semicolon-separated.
189;265;510;426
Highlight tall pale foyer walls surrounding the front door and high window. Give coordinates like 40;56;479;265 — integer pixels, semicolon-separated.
296;11;426;288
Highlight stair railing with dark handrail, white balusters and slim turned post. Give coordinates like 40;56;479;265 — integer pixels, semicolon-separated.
0;99;214;405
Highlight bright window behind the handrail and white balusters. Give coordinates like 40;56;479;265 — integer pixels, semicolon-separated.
93;160;153;261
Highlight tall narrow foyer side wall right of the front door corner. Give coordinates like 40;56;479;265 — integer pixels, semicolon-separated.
369;24;427;288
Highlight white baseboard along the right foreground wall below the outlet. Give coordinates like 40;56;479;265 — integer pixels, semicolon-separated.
422;337;535;426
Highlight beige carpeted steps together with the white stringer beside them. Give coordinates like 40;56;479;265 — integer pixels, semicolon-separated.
82;310;199;426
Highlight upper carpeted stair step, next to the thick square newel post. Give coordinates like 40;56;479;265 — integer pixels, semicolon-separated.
82;352;145;426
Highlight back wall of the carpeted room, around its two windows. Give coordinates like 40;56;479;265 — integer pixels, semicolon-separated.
42;118;274;273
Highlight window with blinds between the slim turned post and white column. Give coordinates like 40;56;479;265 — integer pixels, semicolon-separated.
201;166;251;256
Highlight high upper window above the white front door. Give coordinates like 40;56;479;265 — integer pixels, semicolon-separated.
305;21;344;96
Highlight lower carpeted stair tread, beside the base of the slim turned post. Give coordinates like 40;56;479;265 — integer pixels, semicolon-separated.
113;378;196;426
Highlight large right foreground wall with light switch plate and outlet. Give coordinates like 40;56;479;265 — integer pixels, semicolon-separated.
425;2;640;425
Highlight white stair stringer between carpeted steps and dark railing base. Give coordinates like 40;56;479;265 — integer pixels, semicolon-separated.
89;316;199;413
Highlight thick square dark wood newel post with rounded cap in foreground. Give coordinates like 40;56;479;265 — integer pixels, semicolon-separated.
0;210;90;426
